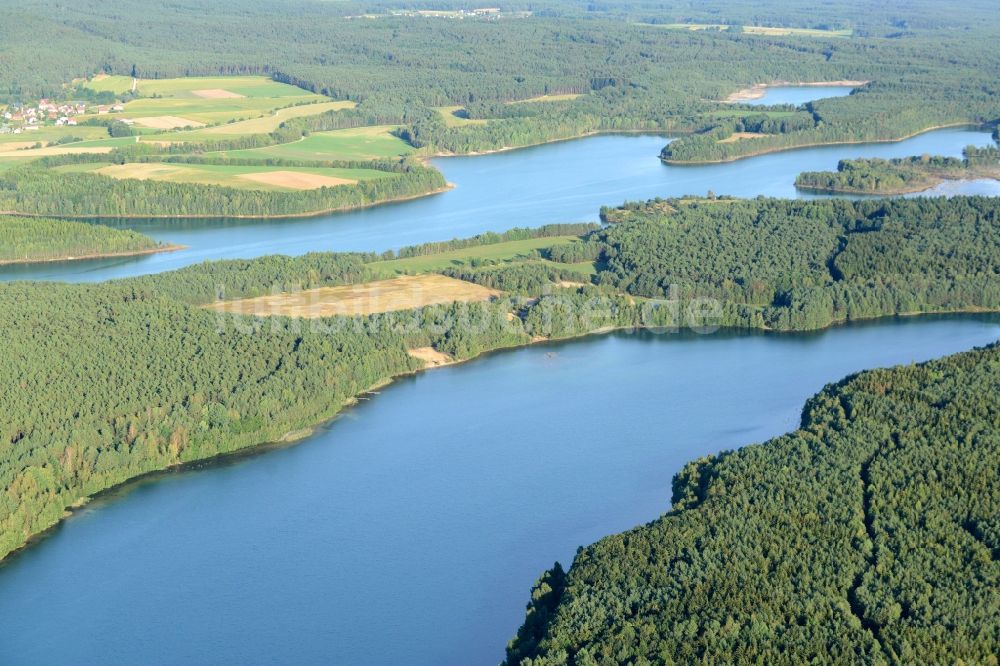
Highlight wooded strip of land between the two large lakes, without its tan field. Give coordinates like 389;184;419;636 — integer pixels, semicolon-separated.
0;197;1000;554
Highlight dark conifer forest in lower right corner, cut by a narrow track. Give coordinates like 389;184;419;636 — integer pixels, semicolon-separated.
507;346;1000;666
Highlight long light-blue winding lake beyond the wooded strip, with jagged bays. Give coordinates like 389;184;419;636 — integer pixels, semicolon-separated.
0;126;993;282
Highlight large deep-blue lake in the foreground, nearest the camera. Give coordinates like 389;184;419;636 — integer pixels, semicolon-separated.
0;317;1000;666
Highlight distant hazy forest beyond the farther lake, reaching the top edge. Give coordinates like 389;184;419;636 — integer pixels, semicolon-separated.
0;0;1000;169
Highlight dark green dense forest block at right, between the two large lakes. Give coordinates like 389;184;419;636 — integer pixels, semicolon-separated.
591;197;1000;329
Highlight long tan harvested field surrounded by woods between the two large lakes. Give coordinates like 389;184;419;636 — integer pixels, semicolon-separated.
206;275;500;318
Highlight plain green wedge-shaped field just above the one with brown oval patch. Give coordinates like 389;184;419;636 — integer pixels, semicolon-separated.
224;125;413;160
